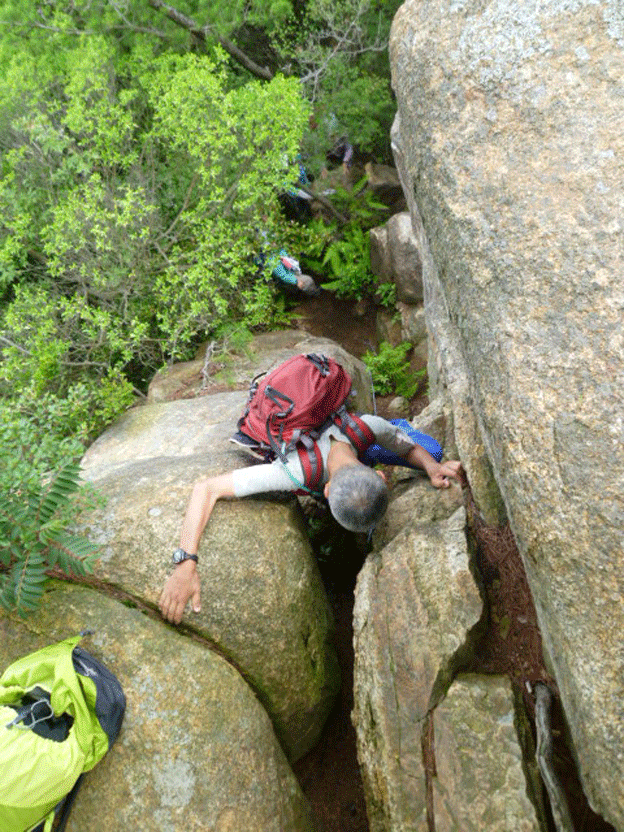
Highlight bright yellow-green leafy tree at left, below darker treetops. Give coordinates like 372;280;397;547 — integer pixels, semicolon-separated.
0;35;307;437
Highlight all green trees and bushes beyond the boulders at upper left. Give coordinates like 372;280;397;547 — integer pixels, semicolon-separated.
0;0;397;456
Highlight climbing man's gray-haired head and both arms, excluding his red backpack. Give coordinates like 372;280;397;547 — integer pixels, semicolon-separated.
159;390;462;624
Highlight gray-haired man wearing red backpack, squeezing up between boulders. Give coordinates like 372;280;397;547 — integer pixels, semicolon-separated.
159;355;462;624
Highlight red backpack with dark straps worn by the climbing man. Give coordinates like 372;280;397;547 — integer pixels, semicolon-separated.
232;354;376;491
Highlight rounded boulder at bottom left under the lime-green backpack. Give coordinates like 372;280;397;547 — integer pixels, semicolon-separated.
0;585;312;832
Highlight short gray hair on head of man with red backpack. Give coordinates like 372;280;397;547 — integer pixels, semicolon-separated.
327;465;388;532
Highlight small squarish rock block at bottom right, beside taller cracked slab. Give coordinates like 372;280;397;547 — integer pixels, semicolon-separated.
433;676;542;832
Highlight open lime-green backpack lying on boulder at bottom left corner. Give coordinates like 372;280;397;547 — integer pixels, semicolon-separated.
0;636;126;832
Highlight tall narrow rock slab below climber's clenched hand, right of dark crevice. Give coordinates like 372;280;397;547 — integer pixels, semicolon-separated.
353;500;482;832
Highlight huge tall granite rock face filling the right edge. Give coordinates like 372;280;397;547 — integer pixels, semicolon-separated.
390;0;624;829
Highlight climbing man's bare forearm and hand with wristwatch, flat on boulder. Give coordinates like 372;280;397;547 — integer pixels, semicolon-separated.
158;473;234;624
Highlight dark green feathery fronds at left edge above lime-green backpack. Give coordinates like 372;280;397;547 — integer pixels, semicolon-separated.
0;462;98;616
